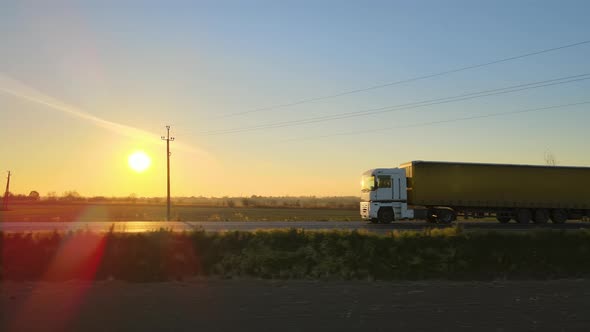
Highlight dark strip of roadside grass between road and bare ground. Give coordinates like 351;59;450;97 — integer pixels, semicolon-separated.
0;227;590;281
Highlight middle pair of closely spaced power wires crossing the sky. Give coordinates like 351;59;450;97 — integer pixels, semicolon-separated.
201;73;590;135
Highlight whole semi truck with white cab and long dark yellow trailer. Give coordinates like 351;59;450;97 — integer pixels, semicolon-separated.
360;161;590;224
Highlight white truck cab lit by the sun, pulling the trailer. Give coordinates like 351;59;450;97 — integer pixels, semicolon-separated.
360;168;414;223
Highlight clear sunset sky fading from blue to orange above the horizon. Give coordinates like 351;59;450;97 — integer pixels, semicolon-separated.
0;0;590;197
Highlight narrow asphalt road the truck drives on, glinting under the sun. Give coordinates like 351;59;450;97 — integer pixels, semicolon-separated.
0;221;590;233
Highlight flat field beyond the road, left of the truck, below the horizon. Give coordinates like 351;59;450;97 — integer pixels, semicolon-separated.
0;202;360;222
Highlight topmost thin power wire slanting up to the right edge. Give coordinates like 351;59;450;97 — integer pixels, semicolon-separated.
217;40;590;118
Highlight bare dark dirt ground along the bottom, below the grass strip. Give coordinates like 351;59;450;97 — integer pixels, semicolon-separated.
0;279;590;332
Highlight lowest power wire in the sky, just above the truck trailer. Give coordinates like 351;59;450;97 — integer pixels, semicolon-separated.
281;101;590;142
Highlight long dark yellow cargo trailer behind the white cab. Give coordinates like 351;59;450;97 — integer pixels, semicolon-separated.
400;161;590;209
